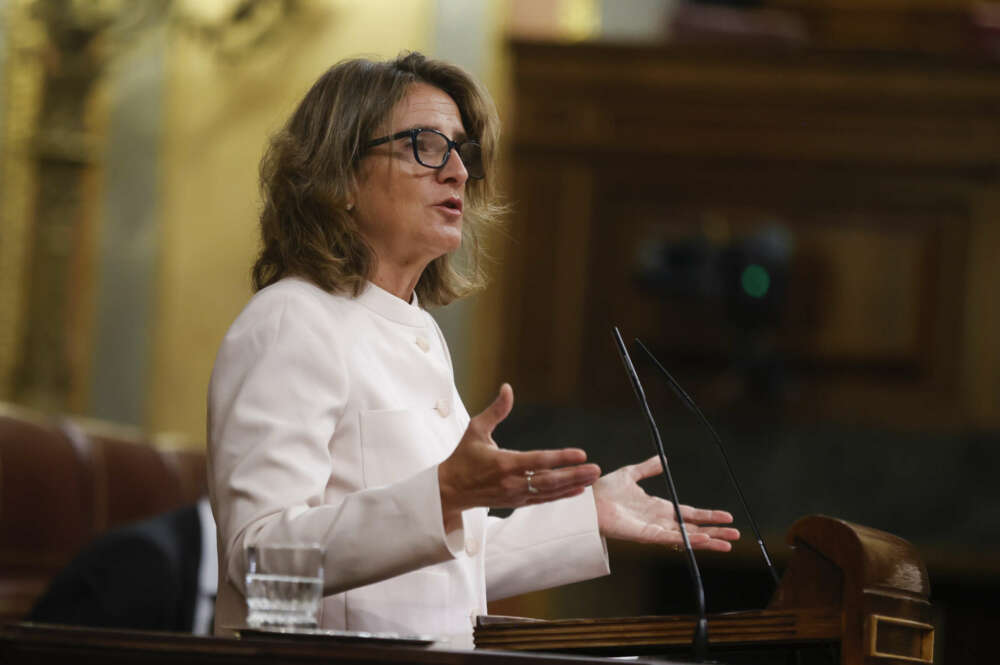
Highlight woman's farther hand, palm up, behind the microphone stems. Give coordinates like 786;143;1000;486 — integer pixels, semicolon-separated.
594;457;740;552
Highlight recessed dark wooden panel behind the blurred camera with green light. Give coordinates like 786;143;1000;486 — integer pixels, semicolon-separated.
593;197;948;370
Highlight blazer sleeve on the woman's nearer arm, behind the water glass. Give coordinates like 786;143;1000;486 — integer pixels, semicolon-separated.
209;294;464;594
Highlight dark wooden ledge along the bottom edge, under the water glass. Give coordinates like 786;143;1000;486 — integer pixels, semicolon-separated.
0;623;704;665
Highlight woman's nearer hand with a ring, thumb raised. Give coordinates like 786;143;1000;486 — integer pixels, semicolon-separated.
438;383;601;531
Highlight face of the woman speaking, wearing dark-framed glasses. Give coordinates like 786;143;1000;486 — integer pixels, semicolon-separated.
353;83;469;281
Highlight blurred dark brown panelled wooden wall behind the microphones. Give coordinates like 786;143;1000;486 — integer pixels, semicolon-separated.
502;42;1000;428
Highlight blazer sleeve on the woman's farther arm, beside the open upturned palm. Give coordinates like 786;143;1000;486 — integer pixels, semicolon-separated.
486;487;611;600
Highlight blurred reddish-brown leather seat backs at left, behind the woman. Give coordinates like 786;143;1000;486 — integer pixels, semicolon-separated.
0;405;206;622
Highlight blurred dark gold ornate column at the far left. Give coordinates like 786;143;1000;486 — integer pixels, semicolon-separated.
12;0;114;411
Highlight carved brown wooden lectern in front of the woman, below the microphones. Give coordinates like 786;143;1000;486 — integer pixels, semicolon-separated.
475;515;934;665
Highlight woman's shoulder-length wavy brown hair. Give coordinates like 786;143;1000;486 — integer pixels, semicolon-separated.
252;53;503;305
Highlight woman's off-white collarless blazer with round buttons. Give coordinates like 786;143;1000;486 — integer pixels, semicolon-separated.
208;278;609;646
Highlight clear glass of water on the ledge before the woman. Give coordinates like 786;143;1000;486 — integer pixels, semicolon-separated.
246;543;323;628
